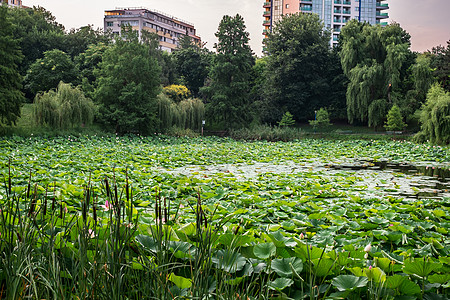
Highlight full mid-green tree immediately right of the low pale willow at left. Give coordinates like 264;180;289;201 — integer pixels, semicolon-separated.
94;29;161;134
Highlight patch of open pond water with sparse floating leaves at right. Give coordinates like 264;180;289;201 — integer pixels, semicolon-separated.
165;160;450;201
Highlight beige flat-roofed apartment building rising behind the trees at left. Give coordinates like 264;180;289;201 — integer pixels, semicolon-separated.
104;7;201;52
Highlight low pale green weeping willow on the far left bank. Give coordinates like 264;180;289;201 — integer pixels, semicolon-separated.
33;82;95;129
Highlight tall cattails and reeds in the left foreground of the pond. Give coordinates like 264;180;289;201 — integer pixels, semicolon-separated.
0;166;270;299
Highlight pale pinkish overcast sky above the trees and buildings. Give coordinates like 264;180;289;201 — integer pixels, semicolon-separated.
22;0;450;56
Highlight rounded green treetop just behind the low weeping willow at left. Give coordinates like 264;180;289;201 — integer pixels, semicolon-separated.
25;49;78;95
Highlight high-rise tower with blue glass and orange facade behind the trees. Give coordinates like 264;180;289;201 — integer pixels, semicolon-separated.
263;0;389;45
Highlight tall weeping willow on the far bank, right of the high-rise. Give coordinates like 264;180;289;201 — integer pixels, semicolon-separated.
340;20;410;127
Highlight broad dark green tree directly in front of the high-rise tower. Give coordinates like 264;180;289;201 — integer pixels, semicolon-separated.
263;14;338;123
